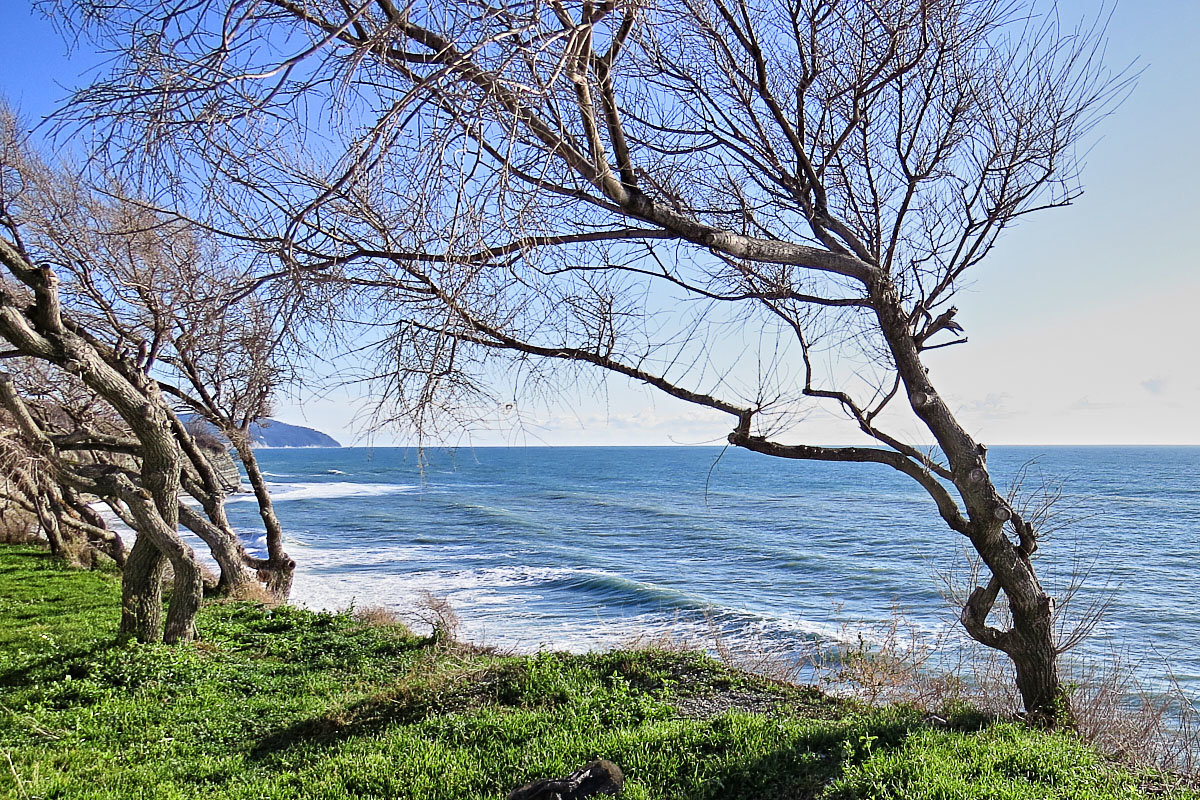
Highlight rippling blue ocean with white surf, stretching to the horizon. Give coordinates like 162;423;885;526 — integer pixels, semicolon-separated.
220;447;1200;696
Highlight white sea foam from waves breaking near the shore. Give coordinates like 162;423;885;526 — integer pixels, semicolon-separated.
91;494;936;652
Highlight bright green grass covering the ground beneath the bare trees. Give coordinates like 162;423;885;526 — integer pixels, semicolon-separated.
0;548;1196;800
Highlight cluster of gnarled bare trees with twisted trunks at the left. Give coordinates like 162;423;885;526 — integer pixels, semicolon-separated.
0;109;295;642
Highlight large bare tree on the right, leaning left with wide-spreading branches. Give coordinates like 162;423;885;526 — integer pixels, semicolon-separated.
43;0;1127;722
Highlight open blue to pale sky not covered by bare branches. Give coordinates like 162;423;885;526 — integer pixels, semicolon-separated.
0;0;1200;445
